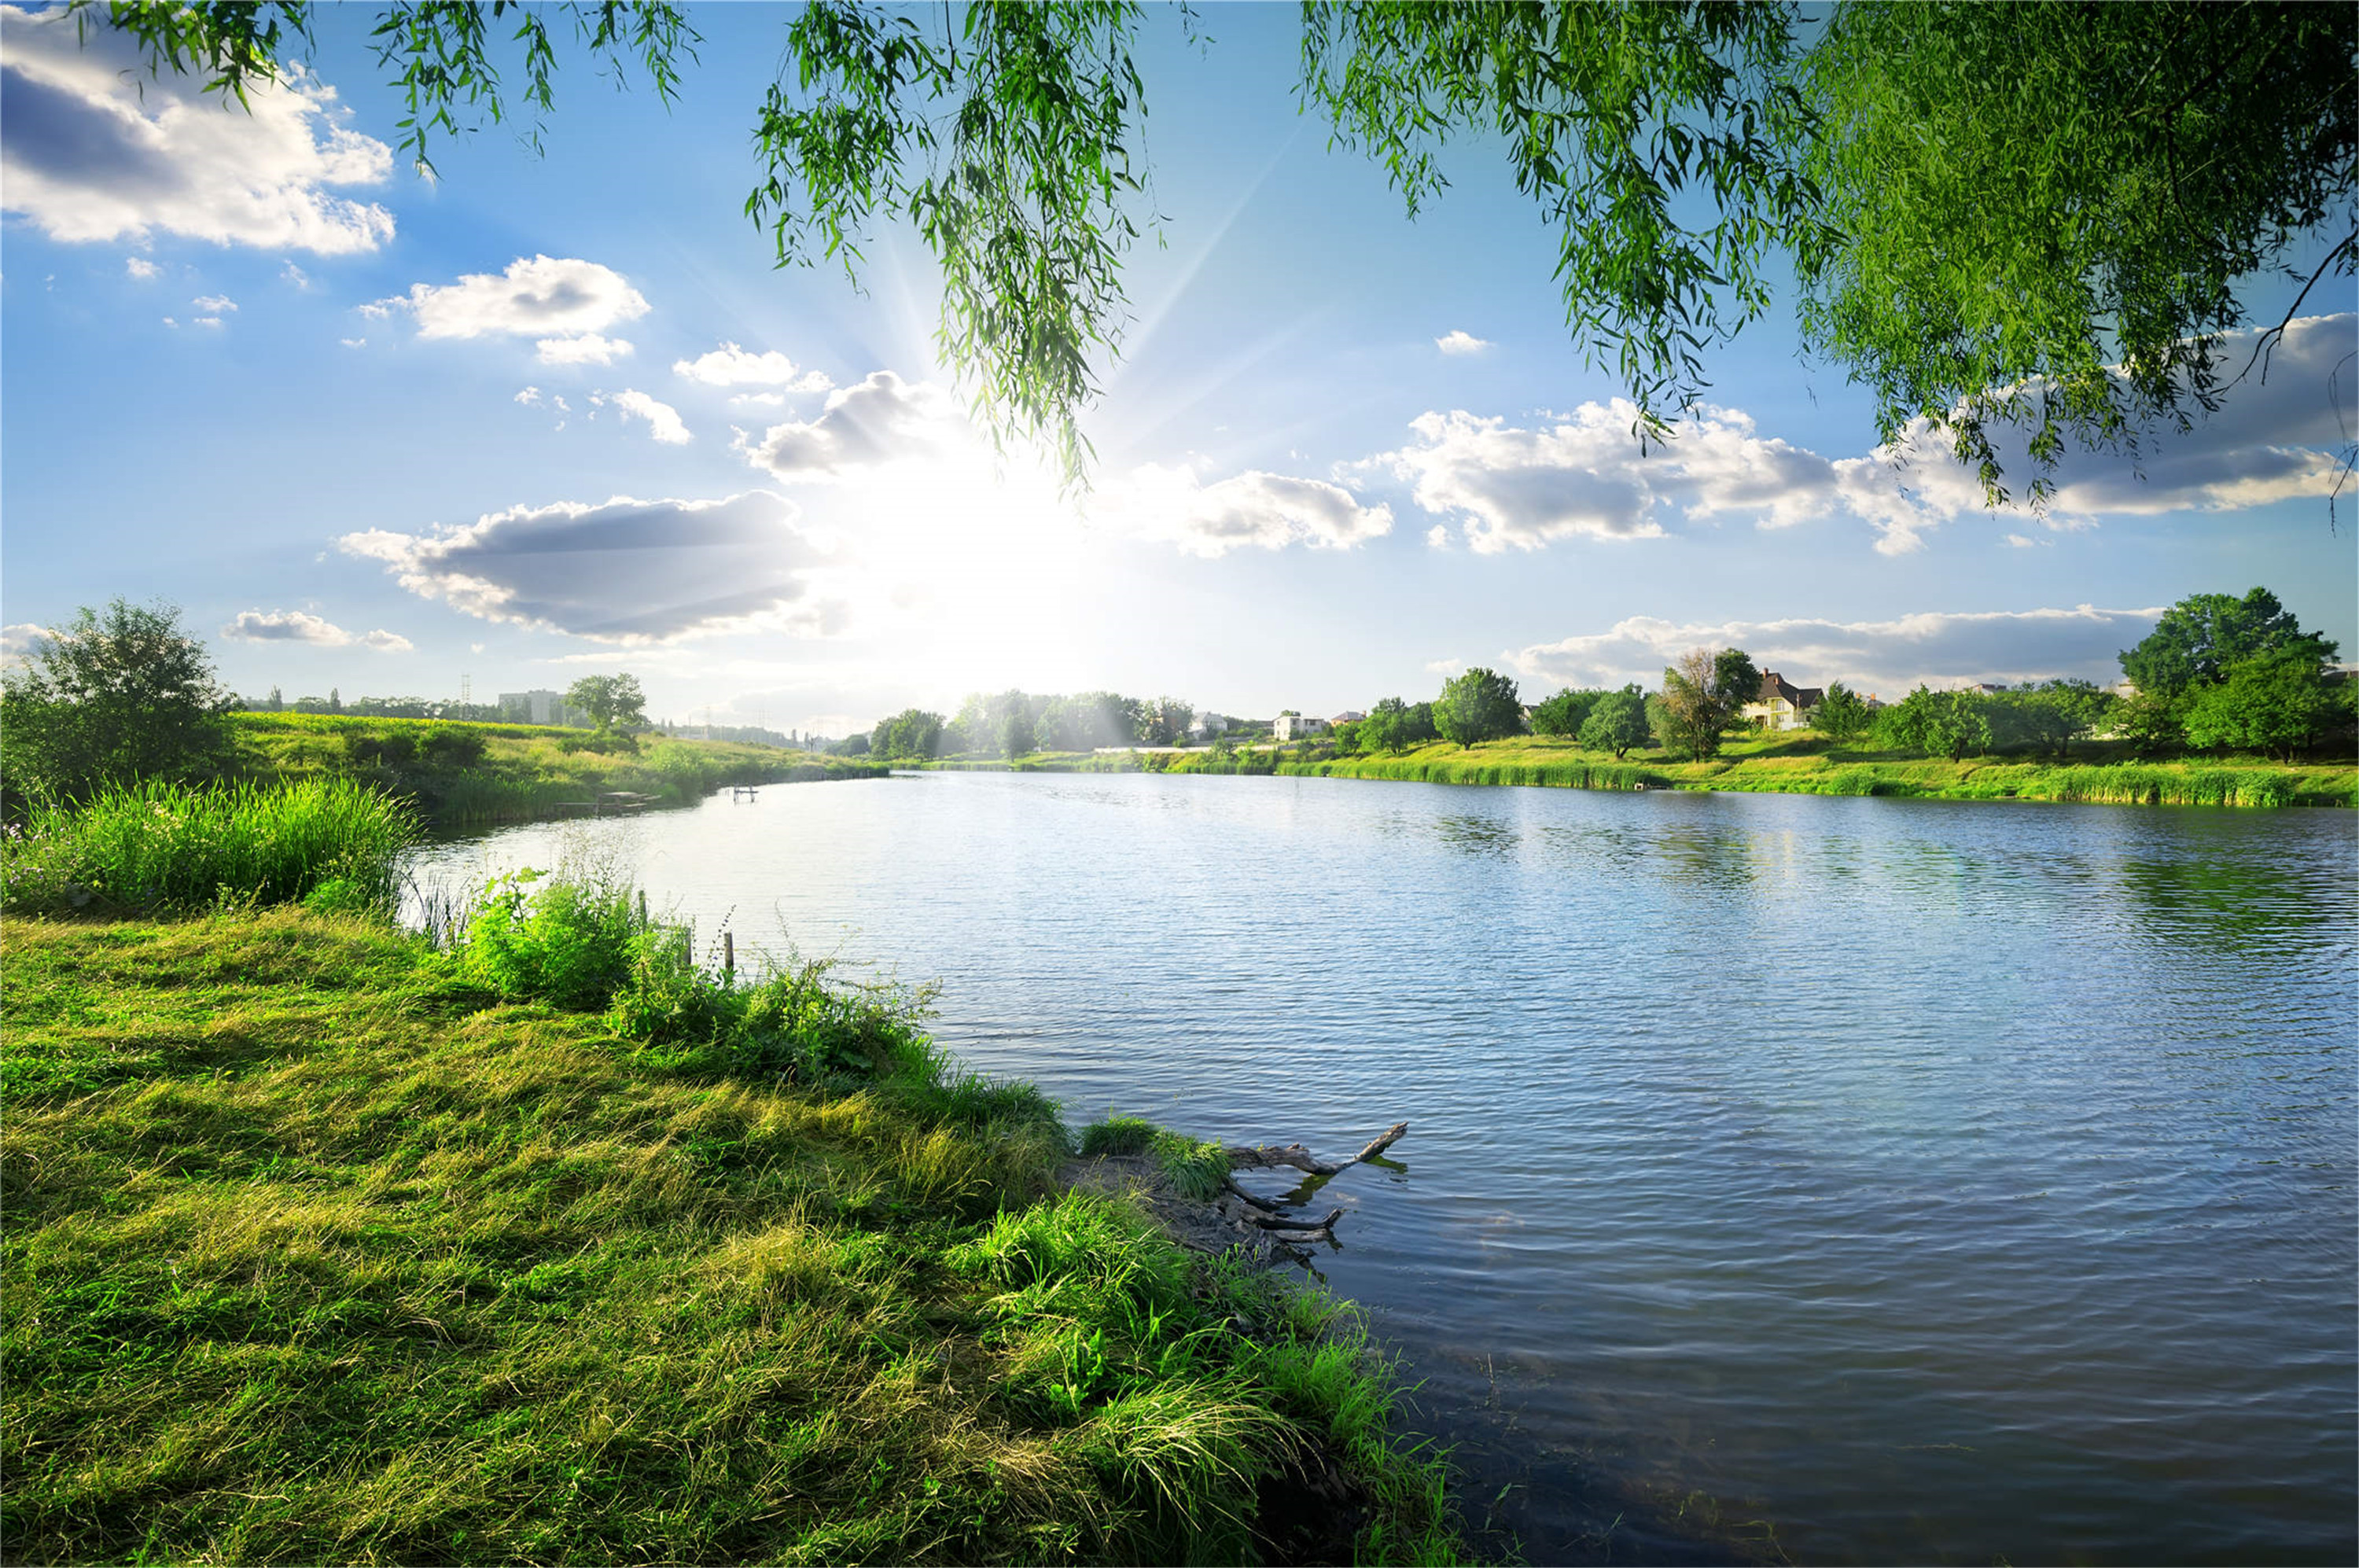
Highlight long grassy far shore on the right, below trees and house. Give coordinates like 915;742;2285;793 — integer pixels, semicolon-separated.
911;736;2359;806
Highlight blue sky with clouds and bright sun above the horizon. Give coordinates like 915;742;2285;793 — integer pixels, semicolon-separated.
0;5;2359;734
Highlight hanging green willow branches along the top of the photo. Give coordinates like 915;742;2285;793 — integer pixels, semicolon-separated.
75;0;2359;498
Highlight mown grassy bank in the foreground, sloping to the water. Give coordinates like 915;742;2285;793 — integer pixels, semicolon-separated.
0;900;1458;1563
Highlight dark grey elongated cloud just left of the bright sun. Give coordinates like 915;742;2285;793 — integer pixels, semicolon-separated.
337;491;840;646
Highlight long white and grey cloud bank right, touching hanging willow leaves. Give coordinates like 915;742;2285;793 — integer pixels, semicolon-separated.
1354;316;2359;554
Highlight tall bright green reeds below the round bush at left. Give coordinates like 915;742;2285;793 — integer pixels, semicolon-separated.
0;778;418;915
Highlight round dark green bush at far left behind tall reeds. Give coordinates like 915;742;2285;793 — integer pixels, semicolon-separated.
0;599;229;801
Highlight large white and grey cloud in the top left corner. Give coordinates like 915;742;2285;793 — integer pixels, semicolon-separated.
0;5;394;255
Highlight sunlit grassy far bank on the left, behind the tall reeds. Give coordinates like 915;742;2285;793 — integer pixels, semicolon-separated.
231;712;887;825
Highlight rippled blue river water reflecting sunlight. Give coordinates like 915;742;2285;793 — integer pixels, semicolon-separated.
422;774;2359;1563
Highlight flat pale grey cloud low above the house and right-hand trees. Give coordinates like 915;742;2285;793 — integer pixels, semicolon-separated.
1503;604;2163;698
